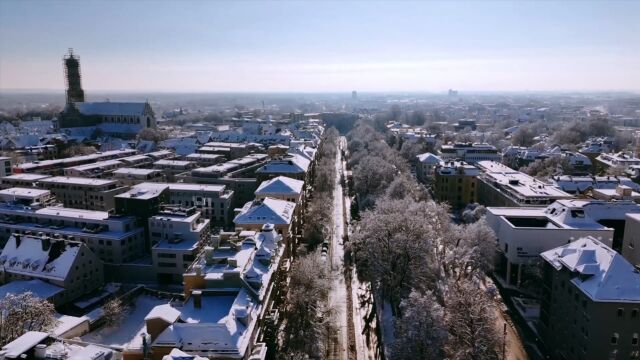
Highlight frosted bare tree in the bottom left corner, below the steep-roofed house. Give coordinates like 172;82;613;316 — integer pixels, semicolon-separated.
0;292;56;344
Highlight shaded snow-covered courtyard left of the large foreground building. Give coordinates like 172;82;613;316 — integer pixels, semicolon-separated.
81;295;167;349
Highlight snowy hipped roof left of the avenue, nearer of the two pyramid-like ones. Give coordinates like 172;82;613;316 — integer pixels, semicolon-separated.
233;197;296;225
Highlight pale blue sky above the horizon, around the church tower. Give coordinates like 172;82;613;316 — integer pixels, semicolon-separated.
0;0;640;92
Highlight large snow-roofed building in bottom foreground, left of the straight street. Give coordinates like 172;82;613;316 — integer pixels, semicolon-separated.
145;224;284;360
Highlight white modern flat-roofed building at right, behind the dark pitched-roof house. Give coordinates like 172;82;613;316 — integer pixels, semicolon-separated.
486;200;640;287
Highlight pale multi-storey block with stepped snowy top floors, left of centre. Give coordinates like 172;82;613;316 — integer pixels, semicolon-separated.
149;207;211;283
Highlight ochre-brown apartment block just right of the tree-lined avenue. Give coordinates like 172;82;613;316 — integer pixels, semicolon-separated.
435;161;480;209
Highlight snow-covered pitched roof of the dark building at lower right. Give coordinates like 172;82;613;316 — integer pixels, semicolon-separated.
541;236;640;303
